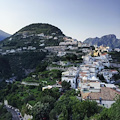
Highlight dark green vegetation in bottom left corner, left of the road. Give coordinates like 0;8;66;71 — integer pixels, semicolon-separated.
0;105;12;120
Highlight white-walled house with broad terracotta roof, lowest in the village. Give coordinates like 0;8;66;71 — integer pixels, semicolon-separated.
82;87;120;108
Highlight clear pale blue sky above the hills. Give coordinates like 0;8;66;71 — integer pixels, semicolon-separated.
0;0;120;41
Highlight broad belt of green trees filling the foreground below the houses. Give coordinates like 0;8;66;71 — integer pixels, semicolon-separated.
0;82;120;120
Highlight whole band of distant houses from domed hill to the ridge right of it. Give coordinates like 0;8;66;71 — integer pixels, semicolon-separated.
0;31;91;56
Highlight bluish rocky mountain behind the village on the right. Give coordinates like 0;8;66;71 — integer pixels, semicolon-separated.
83;34;120;48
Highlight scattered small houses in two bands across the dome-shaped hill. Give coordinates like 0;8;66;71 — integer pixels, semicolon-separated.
0;31;63;55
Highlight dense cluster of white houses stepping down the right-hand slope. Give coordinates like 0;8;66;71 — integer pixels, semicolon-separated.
61;46;120;107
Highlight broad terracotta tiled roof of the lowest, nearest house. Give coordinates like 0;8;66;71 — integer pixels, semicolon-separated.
83;87;120;101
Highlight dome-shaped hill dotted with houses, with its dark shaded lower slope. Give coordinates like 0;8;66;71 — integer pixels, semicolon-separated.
0;23;64;80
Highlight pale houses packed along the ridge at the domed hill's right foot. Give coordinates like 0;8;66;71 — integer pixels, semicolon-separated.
45;36;92;57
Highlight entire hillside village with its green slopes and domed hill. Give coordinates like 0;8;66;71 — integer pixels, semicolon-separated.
0;24;120;120
